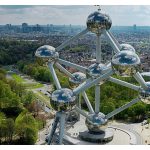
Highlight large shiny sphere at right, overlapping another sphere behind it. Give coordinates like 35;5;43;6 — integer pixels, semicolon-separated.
111;50;140;76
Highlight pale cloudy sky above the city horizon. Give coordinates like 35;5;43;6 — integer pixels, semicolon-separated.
0;5;150;26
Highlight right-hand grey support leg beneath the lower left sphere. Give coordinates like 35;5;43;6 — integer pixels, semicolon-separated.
58;112;66;145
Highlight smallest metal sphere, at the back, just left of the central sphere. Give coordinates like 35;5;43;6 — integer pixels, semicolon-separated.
69;72;86;84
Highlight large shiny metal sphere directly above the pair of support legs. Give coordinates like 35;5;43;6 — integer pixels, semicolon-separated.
50;88;76;111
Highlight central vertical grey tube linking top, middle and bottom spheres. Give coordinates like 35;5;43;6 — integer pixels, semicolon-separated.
95;34;102;113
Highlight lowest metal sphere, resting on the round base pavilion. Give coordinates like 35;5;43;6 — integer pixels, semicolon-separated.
85;112;107;133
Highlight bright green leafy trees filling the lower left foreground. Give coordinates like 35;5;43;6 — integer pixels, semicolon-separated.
0;68;45;144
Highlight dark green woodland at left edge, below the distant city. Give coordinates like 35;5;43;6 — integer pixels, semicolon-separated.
0;39;40;65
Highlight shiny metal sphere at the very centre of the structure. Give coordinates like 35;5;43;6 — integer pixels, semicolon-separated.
87;63;108;78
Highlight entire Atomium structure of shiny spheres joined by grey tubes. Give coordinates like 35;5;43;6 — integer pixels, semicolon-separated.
35;6;150;144
